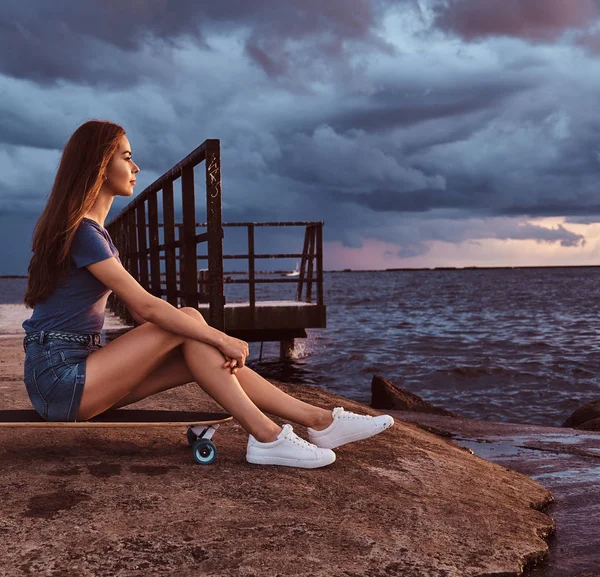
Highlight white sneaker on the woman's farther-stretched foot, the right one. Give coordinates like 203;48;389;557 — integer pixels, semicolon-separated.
308;407;394;449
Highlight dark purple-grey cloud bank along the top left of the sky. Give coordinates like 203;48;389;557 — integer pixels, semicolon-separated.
0;0;390;86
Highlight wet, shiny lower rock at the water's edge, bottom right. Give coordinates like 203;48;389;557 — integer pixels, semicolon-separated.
391;411;600;577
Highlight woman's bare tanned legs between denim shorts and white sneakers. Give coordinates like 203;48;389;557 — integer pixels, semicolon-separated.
78;307;332;441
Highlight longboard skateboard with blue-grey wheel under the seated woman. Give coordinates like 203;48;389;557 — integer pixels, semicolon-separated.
0;409;232;465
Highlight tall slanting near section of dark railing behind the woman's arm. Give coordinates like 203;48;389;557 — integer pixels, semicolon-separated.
106;140;225;330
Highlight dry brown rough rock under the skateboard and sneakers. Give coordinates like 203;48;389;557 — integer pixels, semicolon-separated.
0;338;555;577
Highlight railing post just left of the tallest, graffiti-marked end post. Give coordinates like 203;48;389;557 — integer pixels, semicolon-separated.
181;165;198;309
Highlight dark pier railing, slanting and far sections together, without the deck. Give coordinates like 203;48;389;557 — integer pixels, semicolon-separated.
106;140;324;330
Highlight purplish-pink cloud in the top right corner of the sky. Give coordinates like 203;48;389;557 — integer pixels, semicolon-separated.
434;0;599;41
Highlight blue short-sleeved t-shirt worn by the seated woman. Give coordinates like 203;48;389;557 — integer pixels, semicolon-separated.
21;217;121;334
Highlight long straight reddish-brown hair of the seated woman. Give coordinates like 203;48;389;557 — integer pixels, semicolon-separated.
24;120;125;308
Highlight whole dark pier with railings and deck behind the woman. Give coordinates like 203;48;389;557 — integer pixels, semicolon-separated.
106;140;327;357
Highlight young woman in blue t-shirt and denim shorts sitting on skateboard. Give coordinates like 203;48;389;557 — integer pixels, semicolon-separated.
23;120;393;468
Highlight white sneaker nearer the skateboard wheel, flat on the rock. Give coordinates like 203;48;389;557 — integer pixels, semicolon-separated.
246;425;335;469
